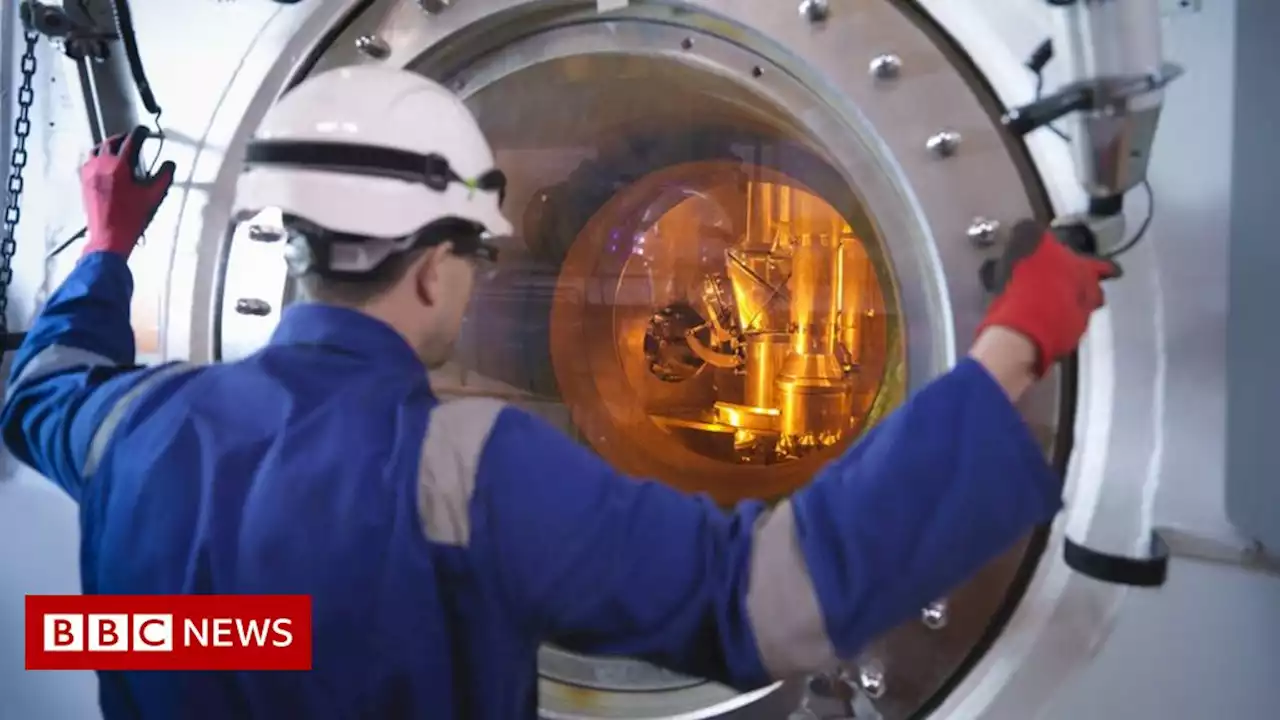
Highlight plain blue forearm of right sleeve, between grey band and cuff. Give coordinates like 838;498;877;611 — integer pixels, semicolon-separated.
794;359;1062;659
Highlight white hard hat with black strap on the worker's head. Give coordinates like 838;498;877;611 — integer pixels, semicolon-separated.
236;65;512;272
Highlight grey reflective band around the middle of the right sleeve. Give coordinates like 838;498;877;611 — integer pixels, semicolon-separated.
746;501;836;679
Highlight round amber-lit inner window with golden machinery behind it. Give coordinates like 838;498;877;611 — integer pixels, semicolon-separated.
540;161;887;502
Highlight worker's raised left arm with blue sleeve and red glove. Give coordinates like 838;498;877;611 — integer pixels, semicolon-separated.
0;128;174;500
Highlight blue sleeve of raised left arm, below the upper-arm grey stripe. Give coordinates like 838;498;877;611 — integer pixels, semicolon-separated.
0;252;165;500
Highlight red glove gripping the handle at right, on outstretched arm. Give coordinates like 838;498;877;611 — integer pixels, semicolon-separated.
978;222;1120;377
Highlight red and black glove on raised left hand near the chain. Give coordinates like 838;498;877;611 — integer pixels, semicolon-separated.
81;127;174;258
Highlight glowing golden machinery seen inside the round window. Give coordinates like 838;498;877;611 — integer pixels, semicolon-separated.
637;172;878;464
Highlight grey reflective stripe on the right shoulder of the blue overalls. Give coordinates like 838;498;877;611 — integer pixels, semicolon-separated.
417;397;507;546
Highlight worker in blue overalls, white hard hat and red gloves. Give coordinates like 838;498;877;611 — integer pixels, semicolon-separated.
3;67;1114;720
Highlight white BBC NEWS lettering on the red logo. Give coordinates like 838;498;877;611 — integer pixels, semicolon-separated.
44;614;293;652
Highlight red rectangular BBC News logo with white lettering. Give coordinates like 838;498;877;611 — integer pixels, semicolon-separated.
27;594;311;670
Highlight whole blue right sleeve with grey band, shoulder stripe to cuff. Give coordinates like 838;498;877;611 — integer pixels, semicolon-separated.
471;360;1060;689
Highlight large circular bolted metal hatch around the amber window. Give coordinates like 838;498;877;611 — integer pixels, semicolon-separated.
215;0;1059;717
